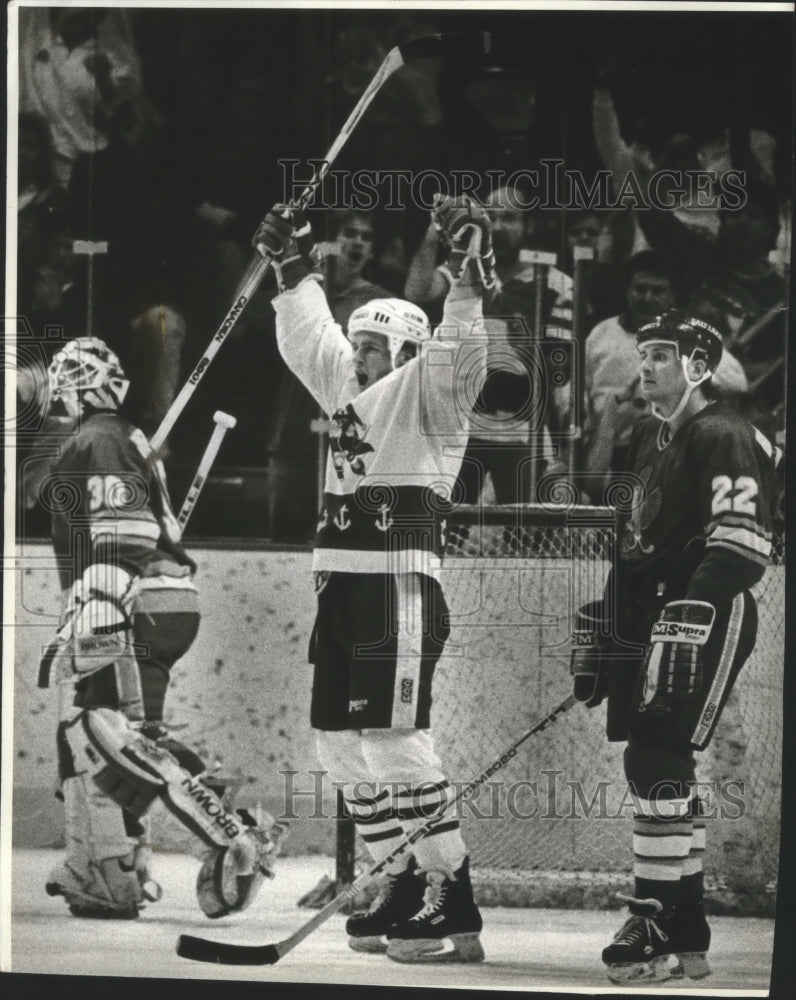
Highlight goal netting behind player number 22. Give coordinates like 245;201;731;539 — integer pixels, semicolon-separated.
410;510;785;912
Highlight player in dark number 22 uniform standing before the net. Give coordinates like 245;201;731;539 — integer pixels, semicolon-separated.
572;310;776;983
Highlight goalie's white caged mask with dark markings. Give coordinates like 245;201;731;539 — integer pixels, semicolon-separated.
48;337;130;418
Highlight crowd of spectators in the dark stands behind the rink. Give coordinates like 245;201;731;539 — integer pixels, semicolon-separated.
17;7;792;539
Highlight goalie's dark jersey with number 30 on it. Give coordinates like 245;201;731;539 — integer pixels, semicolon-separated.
48;412;193;590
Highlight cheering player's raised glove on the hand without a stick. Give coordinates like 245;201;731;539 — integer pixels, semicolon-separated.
431;194;495;288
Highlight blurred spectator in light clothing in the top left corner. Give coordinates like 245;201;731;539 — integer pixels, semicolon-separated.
19;6;148;186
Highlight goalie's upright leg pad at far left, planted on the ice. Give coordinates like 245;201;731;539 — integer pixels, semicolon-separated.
46;774;151;920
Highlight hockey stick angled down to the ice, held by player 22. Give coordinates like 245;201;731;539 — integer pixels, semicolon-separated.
177;695;575;965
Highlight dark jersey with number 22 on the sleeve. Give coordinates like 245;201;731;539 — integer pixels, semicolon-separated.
617;403;776;608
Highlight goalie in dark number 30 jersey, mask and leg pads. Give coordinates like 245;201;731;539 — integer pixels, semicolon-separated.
39;337;279;919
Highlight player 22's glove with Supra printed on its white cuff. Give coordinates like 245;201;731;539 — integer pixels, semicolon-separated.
641;601;716;715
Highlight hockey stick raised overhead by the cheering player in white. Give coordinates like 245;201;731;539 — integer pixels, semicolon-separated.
146;31;492;451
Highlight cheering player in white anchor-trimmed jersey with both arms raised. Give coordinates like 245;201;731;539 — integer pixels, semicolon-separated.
253;198;492;962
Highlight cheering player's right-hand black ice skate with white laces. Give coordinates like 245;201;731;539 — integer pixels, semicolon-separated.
387;858;484;962
